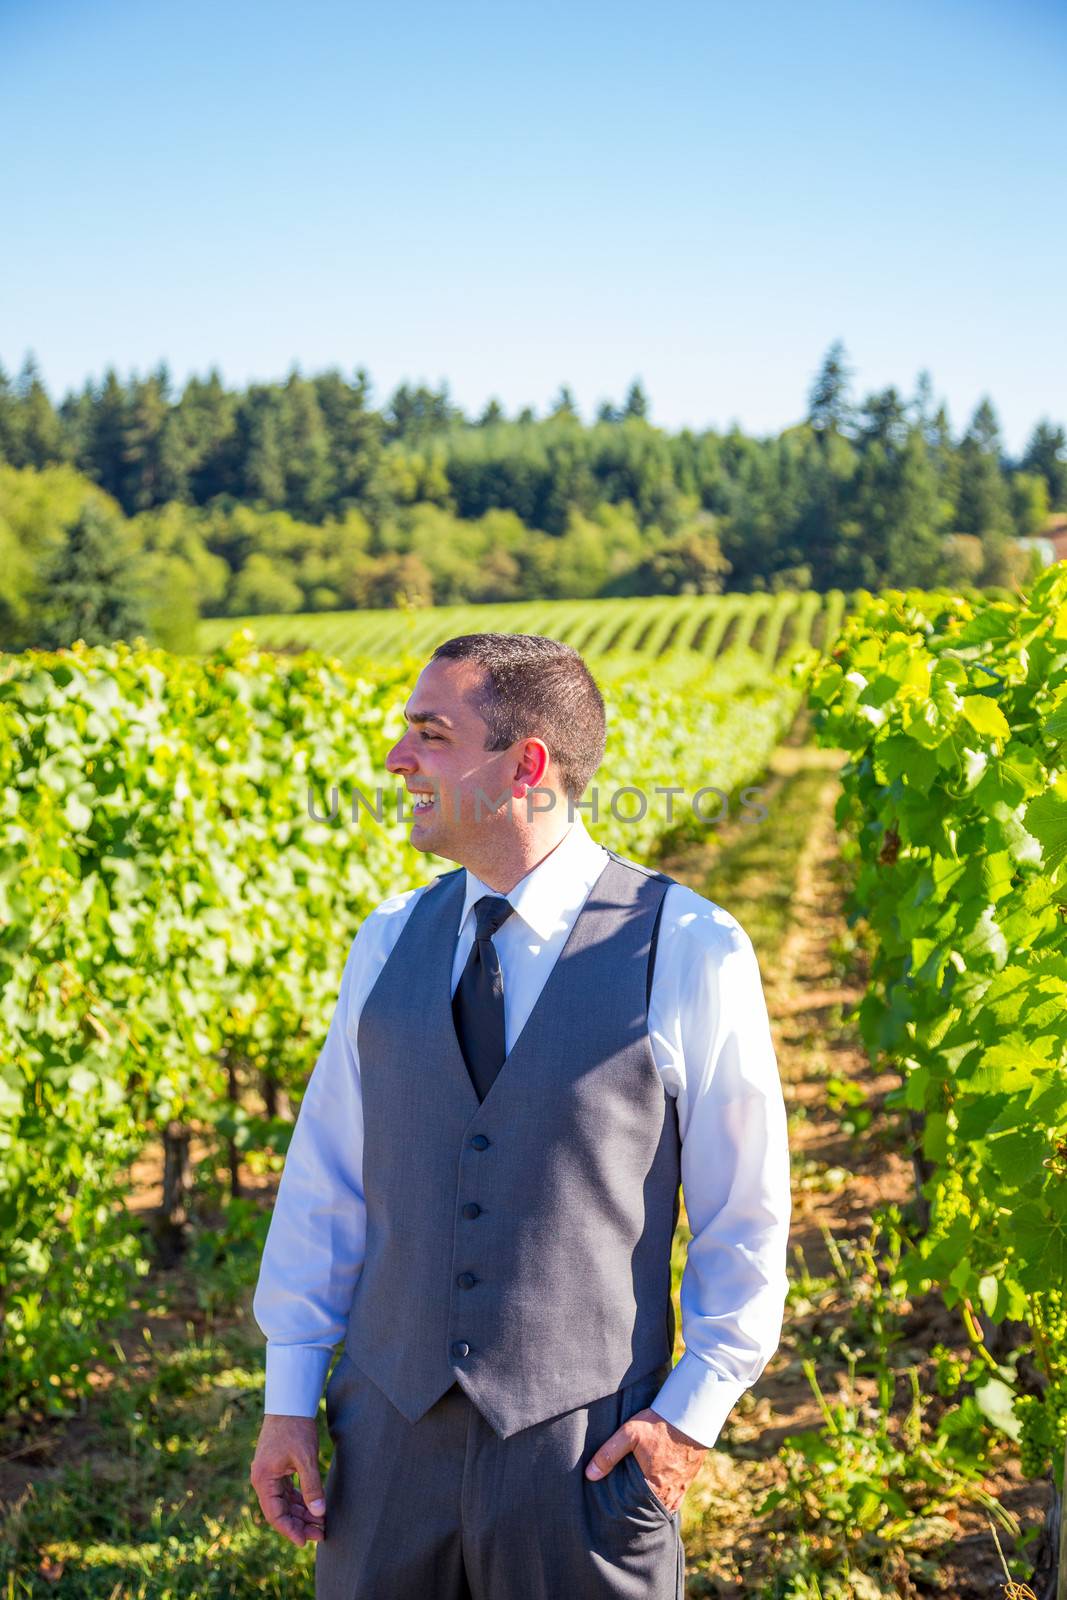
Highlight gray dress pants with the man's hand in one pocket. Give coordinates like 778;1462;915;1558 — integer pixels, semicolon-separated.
315;1352;685;1600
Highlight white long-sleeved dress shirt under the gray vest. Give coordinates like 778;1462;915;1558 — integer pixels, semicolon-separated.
253;816;790;1446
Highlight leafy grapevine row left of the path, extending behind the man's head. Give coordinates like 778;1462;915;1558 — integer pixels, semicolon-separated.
0;613;803;1410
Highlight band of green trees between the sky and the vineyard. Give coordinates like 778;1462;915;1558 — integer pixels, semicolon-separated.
0;341;1067;650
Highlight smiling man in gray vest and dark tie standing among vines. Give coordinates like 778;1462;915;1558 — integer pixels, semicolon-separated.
251;634;790;1600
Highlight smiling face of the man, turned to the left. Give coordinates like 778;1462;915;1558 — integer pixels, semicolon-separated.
386;659;537;862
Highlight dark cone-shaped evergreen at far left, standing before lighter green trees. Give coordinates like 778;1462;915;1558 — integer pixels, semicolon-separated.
35;501;147;650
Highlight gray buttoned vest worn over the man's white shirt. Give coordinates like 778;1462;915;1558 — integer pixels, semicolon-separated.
344;851;680;1438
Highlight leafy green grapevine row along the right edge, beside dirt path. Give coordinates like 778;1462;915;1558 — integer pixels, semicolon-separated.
809;563;1067;1474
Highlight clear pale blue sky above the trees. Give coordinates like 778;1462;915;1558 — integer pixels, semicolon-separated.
0;0;1067;453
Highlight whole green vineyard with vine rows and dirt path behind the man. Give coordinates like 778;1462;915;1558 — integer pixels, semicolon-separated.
0;579;1067;1600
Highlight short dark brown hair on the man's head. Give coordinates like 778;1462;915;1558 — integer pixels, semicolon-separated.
430;634;606;800
